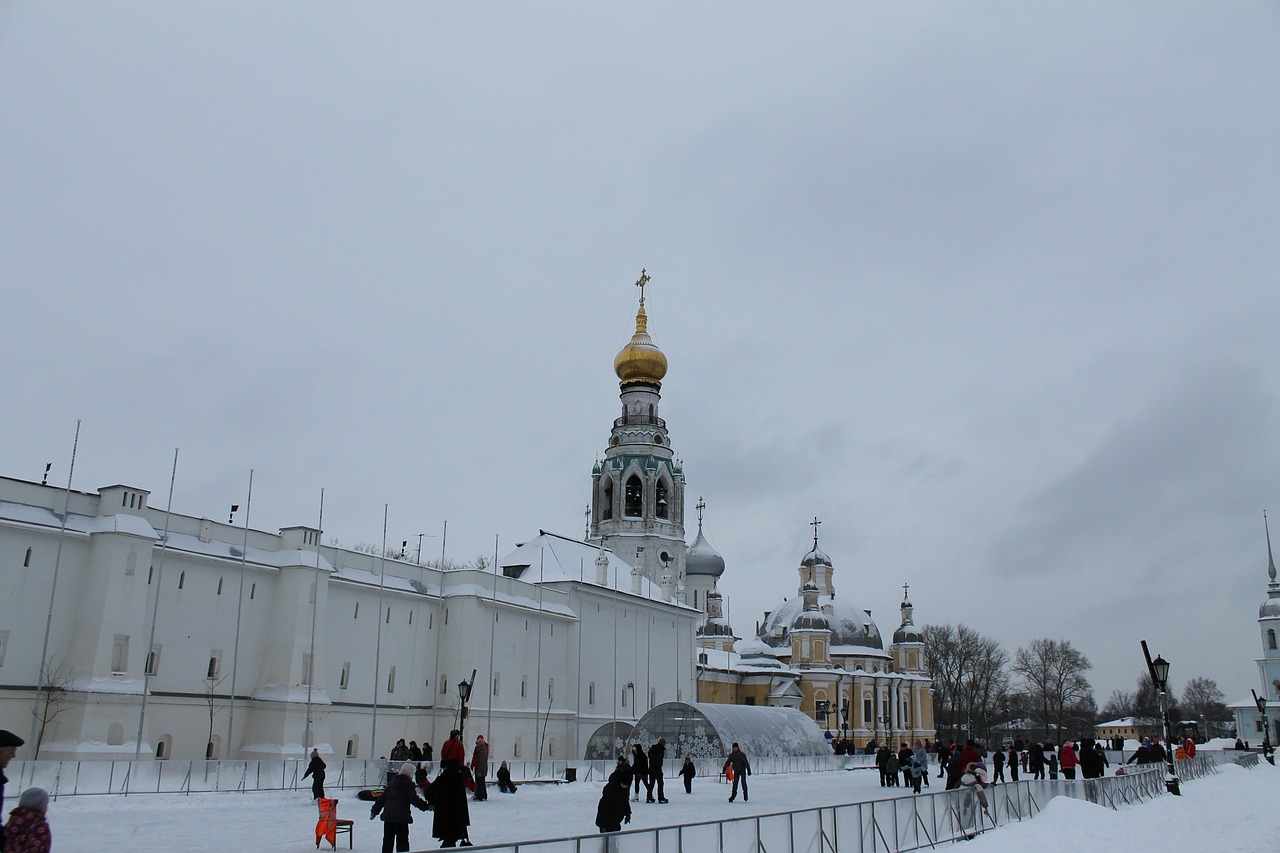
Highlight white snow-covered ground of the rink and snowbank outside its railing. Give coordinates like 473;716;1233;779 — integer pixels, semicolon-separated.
22;763;1280;853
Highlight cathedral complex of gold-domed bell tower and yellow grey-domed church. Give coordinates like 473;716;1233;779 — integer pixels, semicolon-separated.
589;272;934;745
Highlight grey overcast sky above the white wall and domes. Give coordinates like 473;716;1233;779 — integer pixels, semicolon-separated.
0;0;1280;706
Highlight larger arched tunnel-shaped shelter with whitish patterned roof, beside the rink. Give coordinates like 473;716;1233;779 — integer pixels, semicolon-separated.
632;702;831;758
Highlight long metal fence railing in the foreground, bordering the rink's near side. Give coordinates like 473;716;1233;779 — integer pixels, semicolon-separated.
458;762;1172;853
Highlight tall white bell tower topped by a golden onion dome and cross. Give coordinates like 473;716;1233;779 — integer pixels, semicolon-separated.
588;270;685;584
